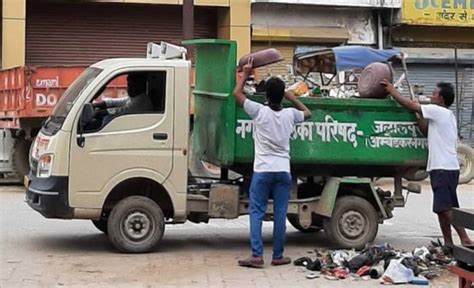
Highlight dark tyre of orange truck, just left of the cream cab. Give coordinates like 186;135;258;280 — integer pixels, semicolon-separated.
10;138;31;183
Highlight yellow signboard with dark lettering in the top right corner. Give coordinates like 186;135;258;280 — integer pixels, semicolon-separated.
402;0;474;26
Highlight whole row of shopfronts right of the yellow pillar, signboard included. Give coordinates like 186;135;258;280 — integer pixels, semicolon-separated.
251;0;474;144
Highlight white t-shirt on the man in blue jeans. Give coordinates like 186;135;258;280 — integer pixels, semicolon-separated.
244;99;304;172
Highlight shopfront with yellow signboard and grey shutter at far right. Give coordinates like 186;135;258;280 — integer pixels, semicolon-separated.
392;0;474;147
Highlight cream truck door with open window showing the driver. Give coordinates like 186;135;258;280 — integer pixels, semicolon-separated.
69;68;174;208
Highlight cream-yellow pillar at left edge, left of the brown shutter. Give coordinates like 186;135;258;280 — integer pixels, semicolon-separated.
1;0;26;69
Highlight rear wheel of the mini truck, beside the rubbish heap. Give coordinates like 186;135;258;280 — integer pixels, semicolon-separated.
323;196;378;249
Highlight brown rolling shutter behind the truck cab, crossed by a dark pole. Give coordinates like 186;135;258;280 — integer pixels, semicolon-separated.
26;1;217;65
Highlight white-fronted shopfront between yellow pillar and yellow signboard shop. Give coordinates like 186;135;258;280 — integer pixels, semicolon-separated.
251;0;401;74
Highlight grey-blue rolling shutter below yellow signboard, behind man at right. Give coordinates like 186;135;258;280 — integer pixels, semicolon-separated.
395;63;474;147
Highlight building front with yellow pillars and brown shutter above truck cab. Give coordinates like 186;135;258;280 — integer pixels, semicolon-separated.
0;0;254;69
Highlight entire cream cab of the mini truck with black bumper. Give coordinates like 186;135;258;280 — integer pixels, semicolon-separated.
25;44;190;252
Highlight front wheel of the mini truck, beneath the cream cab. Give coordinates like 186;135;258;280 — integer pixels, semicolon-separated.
107;196;165;253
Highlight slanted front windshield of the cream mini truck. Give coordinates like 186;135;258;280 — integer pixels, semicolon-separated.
51;67;102;122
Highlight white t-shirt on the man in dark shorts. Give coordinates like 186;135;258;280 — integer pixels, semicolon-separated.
421;104;459;171
